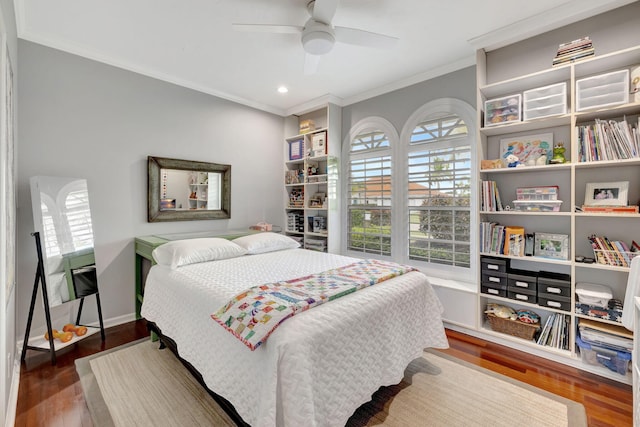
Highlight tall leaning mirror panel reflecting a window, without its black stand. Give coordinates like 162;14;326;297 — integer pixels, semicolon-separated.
31;176;98;307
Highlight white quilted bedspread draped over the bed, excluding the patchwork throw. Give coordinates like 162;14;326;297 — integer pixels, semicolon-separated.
142;249;448;427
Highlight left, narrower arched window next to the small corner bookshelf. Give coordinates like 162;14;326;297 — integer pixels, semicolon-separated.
343;117;398;256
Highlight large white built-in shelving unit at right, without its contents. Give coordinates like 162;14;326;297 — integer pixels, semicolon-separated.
477;41;640;384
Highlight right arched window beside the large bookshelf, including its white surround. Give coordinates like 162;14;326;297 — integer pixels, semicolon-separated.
401;99;475;278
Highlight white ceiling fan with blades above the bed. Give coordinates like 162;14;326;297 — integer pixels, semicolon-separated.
232;0;398;74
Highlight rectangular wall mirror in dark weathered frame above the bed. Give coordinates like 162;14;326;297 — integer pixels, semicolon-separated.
147;156;231;222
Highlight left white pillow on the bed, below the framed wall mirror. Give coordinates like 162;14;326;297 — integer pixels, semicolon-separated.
152;237;247;270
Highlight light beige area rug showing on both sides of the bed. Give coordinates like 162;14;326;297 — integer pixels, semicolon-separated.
76;340;587;427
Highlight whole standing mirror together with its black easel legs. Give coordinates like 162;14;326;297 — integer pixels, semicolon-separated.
21;176;105;365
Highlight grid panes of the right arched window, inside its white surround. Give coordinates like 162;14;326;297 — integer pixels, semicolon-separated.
407;116;471;268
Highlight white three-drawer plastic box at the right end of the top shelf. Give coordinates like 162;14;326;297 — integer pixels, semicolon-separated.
576;69;629;111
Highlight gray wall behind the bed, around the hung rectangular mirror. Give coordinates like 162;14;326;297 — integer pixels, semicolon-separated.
16;40;284;340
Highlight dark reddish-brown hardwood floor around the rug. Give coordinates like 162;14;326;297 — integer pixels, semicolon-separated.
15;320;633;427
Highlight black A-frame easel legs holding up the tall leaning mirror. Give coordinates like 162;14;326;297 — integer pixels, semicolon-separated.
20;231;105;365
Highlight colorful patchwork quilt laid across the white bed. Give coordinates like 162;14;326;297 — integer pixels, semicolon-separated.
211;259;416;350
